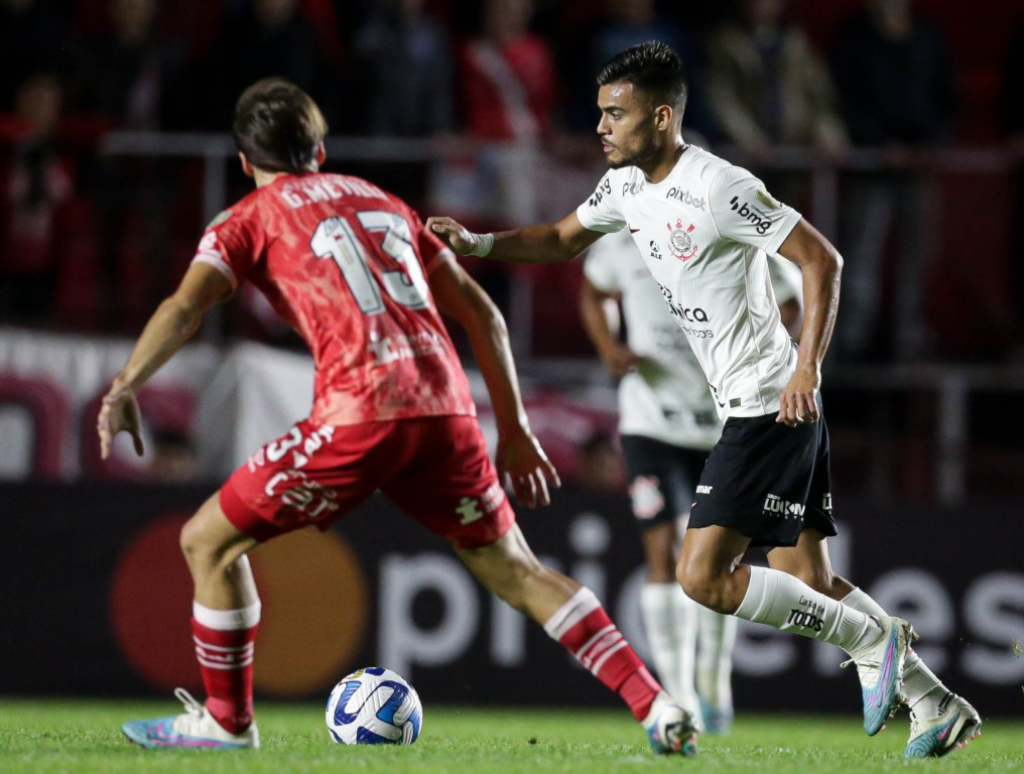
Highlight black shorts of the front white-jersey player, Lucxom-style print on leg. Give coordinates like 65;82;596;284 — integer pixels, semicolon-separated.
689;407;836;548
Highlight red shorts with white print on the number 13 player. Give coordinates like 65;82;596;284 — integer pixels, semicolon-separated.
220;417;515;549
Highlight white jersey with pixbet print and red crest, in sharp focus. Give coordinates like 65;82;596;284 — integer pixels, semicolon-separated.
577;145;801;420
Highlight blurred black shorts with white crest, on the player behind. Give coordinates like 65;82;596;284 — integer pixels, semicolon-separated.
622;435;708;529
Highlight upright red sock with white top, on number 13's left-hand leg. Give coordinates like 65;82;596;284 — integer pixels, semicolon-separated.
191;602;259;734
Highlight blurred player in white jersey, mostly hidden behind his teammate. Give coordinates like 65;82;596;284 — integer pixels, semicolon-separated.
580;229;801;733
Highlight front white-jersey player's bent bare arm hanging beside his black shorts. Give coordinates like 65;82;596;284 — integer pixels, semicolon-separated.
776;220;843;427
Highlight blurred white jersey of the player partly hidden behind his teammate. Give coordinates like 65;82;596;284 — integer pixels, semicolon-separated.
584;230;722;449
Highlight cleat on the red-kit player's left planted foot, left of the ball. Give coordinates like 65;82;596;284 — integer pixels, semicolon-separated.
121;688;259;749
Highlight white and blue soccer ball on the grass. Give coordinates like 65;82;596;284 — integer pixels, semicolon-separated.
325;667;423;744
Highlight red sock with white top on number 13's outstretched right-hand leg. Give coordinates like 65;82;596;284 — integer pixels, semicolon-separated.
544;589;662;721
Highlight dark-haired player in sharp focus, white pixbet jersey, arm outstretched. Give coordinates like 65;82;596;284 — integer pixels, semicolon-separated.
427;42;981;758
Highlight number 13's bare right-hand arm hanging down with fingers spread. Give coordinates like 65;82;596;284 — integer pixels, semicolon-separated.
429;253;561;508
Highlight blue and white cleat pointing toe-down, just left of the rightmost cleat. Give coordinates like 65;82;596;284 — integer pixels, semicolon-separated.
843;615;916;736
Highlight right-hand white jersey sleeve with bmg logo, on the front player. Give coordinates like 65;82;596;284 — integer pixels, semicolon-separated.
708;167;801;253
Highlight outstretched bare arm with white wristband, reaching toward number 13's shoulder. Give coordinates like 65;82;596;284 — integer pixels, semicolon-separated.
426;212;603;263
